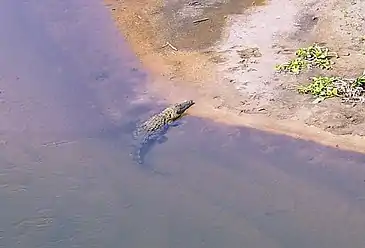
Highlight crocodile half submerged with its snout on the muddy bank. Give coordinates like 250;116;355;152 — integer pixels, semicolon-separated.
133;100;195;165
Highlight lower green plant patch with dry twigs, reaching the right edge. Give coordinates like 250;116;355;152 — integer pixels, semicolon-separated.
298;74;365;103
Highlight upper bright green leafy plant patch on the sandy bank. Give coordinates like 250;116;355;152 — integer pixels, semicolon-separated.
275;44;337;74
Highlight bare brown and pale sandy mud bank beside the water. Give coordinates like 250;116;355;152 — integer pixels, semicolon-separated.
105;0;365;152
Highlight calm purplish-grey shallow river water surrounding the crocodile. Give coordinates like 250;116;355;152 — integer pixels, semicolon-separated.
0;0;365;248
